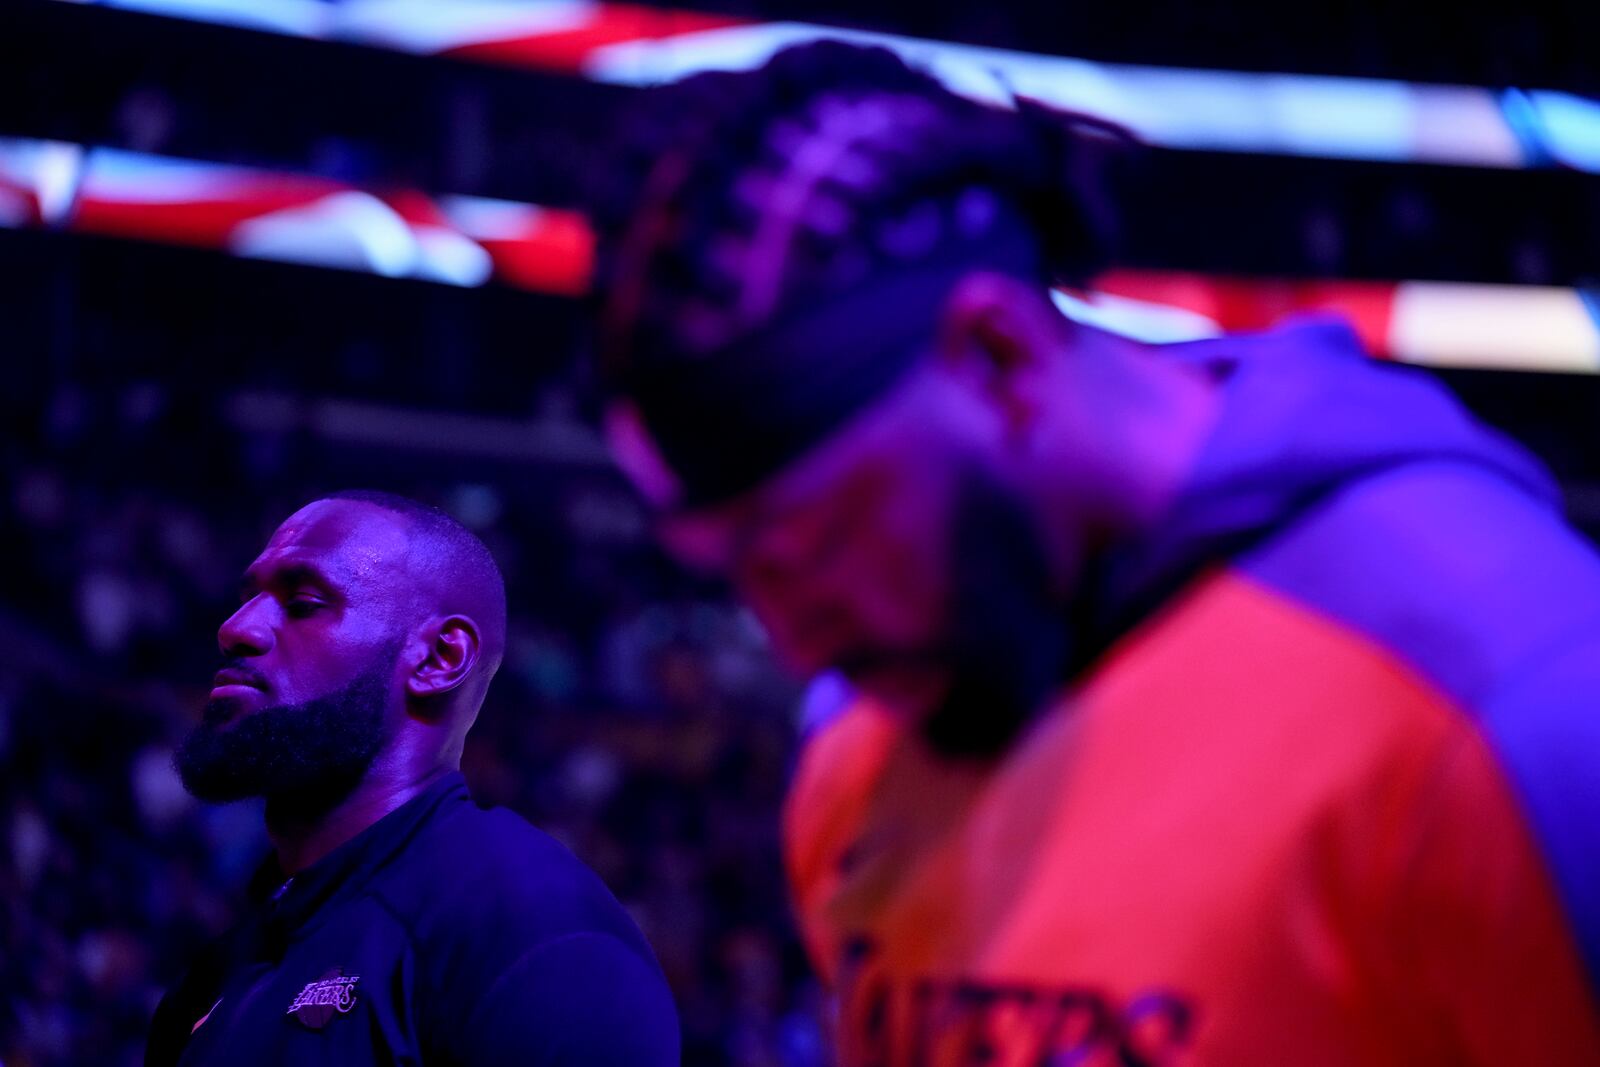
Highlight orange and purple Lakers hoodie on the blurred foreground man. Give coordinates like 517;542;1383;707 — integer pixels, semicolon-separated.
786;325;1600;1067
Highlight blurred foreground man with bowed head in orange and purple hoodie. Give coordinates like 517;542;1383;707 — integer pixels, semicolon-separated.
598;43;1600;1065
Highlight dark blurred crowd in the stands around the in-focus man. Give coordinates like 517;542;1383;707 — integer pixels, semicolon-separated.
0;382;827;1067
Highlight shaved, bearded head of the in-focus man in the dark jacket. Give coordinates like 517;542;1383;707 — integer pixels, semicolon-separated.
176;490;506;819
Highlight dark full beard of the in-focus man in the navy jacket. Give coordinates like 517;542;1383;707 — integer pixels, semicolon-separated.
173;656;394;822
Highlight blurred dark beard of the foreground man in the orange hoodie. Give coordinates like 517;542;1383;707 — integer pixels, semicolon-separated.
923;470;1070;758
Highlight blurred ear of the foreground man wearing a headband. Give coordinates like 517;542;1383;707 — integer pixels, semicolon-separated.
939;272;1061;435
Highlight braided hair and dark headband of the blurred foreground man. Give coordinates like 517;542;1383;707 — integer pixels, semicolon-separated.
592;42;1125;506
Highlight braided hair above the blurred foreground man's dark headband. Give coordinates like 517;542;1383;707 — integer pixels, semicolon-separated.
592;40;1128;505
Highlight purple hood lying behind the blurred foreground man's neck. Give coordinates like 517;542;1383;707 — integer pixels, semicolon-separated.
1080;310;1560;662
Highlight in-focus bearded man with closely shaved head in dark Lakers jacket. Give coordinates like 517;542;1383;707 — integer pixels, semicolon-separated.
146;491;678;1067
